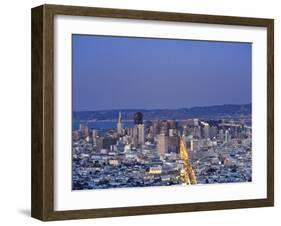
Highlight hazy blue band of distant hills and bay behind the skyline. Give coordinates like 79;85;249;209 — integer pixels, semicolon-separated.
73;104;252;121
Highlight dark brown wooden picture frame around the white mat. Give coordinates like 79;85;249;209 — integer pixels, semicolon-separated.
31;5;274;221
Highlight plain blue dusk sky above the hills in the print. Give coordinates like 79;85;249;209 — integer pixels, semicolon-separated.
72;35;252;111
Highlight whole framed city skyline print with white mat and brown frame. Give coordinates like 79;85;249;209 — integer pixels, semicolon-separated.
32;5;274;221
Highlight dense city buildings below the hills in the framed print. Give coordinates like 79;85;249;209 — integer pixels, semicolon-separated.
72;112;252;190
